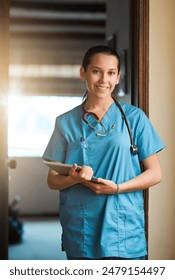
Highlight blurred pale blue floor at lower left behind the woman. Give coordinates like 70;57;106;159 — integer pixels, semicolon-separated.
9;217;66;260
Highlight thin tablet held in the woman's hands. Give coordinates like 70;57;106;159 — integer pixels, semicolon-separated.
43;160;97;183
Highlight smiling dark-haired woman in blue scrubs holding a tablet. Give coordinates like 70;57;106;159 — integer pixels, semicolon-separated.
43;46;164;259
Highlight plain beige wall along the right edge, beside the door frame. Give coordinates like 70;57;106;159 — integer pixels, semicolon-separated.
149;0;175;260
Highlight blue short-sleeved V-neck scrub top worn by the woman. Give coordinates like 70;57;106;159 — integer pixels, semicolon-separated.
43;102;164;258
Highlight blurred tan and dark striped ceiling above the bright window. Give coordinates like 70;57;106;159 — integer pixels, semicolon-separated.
10;0;106;95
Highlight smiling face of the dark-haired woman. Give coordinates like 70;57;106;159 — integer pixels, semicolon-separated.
80;53;120;98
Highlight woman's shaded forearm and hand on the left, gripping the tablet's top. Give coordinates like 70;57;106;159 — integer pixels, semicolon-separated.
47;164;93;190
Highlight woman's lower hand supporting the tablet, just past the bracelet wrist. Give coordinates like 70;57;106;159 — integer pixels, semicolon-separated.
84;178;118;194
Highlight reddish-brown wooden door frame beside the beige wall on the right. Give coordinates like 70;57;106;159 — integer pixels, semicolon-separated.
131;0;149;256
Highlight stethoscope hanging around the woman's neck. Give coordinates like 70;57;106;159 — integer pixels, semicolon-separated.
82;98;138;155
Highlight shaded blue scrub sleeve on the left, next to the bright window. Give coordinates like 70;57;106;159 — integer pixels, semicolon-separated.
42;118;67;162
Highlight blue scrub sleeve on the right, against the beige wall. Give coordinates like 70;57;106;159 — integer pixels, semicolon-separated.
137;112;165;161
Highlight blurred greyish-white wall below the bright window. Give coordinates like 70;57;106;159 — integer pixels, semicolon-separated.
9;158;59;215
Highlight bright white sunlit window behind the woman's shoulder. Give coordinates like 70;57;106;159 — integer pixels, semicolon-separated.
8;95;82;157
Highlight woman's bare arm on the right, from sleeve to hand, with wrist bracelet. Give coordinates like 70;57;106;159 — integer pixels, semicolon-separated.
82;154;162;194
